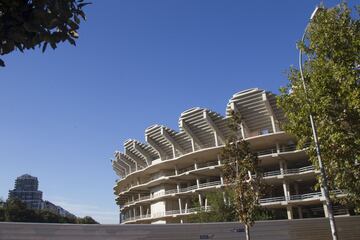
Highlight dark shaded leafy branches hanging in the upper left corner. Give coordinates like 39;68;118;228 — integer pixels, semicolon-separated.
0;0;89;66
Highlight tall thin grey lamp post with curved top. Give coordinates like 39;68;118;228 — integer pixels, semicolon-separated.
299;7;338;240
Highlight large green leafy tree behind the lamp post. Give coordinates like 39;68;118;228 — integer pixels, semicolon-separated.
278;3;360;211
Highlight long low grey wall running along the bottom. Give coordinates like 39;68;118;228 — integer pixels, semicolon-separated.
0;216;360;240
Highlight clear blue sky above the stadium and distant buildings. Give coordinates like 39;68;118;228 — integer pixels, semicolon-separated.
0;0;351;223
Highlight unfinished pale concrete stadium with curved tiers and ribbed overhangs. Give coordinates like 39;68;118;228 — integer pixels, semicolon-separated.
112;88;347;223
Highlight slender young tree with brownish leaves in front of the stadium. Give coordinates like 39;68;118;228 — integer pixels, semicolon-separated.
221;112;261;240
